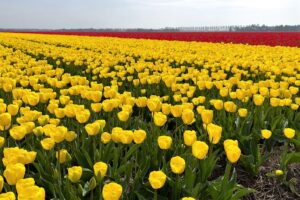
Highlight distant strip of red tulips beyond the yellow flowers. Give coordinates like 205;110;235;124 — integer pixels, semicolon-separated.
25;32;300;47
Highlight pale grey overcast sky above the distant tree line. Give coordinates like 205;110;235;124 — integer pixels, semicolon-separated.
0;0;300;29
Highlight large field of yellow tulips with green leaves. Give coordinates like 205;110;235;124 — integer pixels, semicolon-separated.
0;33;300;200
